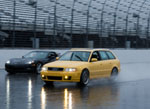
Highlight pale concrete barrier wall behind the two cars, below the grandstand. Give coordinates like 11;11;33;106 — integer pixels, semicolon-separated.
0;49;150;69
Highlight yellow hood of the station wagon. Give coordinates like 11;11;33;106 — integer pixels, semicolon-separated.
45;61;88;68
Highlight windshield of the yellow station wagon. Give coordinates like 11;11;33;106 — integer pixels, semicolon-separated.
59;51;90;62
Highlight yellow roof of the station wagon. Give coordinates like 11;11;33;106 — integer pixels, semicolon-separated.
70;48;110;52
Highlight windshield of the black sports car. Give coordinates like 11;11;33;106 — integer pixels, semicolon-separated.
24;51;48;59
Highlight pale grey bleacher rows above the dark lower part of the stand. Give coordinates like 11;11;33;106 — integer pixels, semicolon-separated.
0;0;150;33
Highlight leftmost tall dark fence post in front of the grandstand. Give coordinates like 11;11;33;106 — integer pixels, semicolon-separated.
12;0;16;47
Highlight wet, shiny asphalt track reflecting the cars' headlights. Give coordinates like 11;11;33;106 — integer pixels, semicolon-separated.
0;63;150;109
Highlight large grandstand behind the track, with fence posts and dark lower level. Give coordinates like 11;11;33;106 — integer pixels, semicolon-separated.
0;0;150;48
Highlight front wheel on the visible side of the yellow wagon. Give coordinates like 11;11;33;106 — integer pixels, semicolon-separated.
79;70;89;86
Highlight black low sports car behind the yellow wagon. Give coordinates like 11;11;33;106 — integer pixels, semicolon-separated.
5;51;58;73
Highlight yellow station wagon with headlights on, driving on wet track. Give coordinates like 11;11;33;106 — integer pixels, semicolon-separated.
41;49;120;85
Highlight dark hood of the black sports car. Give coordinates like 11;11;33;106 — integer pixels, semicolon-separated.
10;58;34;64
